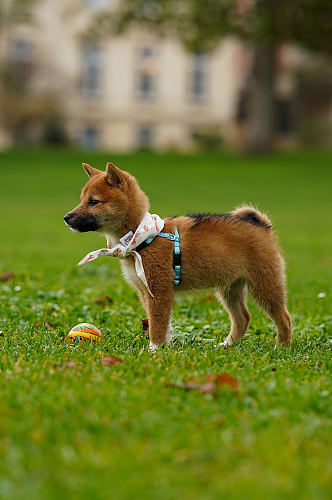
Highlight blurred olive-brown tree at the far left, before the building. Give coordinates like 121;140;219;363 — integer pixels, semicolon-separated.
0;0;68;145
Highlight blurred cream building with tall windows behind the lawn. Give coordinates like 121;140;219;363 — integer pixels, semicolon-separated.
0;0;331;150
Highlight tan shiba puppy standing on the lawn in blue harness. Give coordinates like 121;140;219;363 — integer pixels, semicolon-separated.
64;163;292;350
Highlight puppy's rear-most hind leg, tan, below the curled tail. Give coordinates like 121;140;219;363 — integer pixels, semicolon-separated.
249;273;292;345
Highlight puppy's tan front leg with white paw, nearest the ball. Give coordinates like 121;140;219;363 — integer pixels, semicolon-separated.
148;291;173;351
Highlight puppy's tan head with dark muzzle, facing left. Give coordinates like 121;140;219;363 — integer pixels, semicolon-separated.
64;163;149;233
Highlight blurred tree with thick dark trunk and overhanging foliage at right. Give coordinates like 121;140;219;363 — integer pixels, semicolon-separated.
107;0;332;152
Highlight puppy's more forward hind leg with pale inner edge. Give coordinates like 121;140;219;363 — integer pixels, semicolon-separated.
217;279;250;345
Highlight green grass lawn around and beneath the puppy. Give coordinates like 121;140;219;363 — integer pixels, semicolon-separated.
0;151;332;500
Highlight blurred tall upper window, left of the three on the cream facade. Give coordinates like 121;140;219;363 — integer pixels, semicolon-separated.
82;45;101;97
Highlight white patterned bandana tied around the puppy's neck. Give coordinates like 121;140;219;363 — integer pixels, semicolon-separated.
77;212;165;297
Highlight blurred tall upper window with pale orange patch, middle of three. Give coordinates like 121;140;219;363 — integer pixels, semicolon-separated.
137;47;157;100
